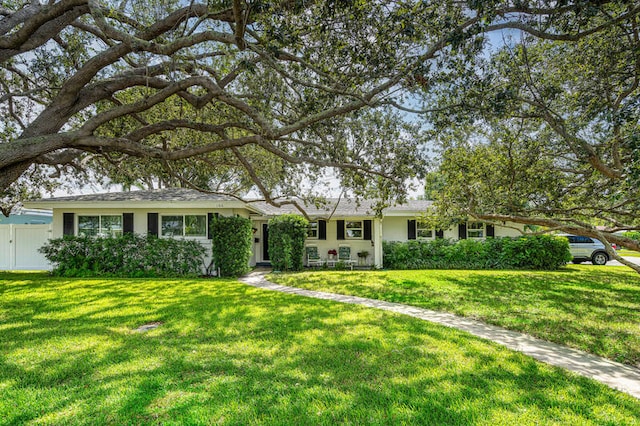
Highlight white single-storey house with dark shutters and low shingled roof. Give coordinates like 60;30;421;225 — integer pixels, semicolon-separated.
25;188;522;267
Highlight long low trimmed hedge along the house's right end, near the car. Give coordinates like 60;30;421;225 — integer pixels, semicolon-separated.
383;235;572;270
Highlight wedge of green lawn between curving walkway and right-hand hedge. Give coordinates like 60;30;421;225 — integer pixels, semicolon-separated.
270;265;640;366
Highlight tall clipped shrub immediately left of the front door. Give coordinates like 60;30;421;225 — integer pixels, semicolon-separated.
210;216;252;277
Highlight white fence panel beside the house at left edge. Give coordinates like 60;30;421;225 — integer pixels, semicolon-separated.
0;225;51;271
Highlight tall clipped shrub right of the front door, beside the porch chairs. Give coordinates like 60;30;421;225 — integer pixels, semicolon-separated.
269;214;309;271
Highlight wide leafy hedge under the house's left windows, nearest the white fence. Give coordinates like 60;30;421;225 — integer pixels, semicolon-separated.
40;234;204;277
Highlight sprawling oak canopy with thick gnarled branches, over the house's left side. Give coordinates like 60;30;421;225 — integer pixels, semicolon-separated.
0;0;638;215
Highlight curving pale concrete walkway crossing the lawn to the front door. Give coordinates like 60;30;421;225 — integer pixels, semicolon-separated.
240;271;640;399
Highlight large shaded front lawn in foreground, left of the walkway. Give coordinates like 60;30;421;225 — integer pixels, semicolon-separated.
0;273;640;425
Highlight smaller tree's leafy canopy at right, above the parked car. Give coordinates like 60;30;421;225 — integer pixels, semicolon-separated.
420;1;640;272
